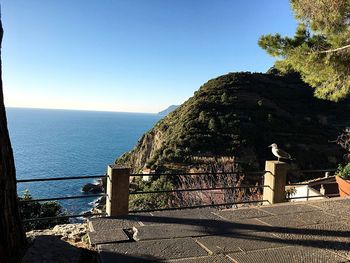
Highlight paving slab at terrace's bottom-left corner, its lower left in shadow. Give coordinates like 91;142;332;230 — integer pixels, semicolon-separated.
98;238;208;263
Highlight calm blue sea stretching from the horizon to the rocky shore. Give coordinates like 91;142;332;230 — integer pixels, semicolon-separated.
6;108;161;213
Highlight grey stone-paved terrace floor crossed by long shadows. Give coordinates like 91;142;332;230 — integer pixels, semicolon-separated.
89;198;350;263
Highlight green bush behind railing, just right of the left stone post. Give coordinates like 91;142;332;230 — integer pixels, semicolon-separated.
129;176;173;210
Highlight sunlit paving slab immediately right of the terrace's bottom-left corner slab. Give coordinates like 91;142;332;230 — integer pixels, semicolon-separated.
196;232;285;254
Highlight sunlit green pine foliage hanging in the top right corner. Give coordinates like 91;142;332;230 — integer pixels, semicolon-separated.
259;0;350;101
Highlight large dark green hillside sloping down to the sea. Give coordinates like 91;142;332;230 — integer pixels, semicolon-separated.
116;73;349;173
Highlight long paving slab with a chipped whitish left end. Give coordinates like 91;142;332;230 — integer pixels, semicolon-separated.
133;219;268;240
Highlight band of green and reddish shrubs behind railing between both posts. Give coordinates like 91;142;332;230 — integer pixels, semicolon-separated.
129;157;262;210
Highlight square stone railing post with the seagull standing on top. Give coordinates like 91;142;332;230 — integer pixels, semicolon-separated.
263;161;288;204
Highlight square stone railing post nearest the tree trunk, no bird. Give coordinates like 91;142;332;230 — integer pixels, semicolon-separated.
106;165;130;216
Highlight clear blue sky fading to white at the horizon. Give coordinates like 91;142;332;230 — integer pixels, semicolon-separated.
1;0;296;112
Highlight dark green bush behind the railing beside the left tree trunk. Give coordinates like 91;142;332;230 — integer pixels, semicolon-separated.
18;190;69;231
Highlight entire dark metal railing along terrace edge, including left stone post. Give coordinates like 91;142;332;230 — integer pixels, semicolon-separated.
17;166;342;222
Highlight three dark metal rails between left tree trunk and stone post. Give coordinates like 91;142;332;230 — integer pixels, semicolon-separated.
16;175;106;222
